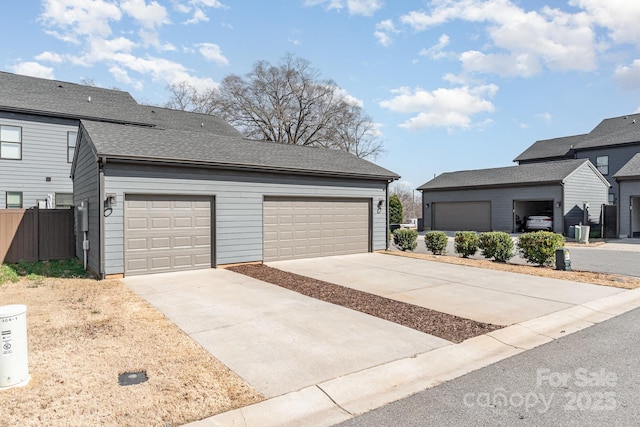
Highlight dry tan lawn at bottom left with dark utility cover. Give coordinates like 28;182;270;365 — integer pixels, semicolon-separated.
0;279;263;427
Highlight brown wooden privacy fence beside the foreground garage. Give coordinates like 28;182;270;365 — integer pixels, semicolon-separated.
0;209;75;263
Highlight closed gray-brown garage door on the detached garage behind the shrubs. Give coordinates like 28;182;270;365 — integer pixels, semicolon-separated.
433;202;491;231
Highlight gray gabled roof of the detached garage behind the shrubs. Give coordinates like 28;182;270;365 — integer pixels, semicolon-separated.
418;159;609;190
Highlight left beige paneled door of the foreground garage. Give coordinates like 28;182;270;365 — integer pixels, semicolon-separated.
124;195;211;275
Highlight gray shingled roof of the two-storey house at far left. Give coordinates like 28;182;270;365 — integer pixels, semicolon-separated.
0;72;151;124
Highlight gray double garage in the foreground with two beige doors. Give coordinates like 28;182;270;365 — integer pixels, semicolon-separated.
72;120;398;277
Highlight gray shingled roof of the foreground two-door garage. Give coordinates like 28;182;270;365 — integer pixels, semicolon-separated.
81;120;399;180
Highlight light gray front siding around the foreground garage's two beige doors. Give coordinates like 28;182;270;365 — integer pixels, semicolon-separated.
100;162;387;274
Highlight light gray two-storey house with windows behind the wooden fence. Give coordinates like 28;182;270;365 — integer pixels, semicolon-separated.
0;72;151;209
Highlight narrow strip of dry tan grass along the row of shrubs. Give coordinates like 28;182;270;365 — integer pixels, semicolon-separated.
380;251;640;289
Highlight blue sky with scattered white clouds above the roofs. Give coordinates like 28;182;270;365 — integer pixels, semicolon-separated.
0;0;640;188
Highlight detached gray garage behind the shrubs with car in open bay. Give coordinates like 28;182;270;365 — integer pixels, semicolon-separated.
418;159;610;233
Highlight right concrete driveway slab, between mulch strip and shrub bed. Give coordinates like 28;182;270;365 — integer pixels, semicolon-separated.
268;253;623;325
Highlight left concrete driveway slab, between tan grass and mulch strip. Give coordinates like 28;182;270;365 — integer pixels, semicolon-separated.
122;269;451;397
